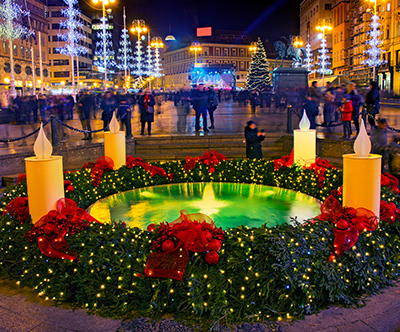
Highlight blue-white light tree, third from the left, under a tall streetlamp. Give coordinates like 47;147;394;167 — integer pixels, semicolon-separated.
93;17;115;85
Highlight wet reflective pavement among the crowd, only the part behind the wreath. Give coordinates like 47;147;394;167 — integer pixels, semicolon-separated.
0;100;400;155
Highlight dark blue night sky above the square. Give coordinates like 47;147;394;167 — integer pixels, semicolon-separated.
80;0;300;42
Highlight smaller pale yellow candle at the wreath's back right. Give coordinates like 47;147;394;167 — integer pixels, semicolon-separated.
293;110;317;165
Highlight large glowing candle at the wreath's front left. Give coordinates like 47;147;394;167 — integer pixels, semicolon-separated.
25;125;64;223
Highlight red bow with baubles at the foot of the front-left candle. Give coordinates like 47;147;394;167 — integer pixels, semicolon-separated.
25;198;97;261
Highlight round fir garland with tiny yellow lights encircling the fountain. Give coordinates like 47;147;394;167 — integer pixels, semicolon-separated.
0;160;400;323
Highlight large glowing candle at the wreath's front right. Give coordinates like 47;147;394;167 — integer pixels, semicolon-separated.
343;120;382;217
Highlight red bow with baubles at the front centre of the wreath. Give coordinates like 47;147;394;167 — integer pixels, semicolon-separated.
144;211;224;280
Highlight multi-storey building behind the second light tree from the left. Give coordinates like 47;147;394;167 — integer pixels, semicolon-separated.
47;6;93;86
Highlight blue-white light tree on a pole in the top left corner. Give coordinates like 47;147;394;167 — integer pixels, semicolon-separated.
0;0;33;98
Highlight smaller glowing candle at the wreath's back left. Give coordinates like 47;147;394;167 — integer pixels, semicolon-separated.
104;112;126;170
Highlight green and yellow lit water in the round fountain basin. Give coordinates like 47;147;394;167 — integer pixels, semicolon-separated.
90;183;319;228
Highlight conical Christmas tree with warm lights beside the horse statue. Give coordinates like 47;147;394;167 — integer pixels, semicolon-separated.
246;38;271;91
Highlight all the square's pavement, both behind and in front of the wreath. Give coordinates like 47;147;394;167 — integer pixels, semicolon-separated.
0;100;400;332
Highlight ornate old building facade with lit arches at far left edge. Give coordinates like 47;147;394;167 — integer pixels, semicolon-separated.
0;0;50;97
